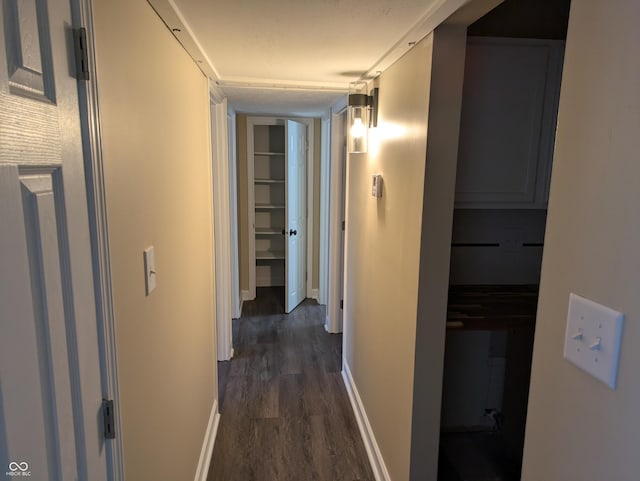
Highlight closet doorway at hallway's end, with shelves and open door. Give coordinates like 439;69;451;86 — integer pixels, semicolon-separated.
238;116;319;313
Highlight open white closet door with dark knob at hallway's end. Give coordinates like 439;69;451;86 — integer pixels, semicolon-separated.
285;120;307;313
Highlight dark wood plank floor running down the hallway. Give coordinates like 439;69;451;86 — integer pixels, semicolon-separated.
207;288;374;481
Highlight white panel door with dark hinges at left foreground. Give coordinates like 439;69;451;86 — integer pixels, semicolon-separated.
0;0;107;481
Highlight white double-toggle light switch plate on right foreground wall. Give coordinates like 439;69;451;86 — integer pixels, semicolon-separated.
564;294;624;389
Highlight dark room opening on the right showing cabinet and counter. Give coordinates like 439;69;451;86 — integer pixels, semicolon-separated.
438;0;569;481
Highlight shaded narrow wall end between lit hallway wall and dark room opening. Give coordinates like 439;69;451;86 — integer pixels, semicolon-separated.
411;25;467;481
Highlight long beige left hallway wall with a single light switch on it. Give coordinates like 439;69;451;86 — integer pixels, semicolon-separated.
94;0;216;481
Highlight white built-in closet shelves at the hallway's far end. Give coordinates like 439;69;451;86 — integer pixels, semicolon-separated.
247;117;286;287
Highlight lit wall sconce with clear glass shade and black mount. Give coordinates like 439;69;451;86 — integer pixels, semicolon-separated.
347;81;378;154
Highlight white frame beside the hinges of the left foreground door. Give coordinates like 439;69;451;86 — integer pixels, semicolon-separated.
74;0;124;481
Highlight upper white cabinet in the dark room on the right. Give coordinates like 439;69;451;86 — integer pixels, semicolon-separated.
455;37;564;209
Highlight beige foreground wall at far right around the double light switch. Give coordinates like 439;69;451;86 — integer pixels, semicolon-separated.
522;0;640;481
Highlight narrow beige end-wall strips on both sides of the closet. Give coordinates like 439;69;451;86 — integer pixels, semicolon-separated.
236;114;322;291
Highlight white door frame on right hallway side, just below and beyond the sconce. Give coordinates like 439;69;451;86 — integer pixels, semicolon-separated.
325;96;347;333
